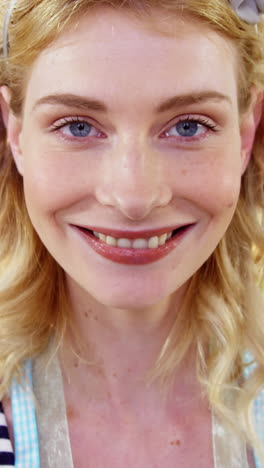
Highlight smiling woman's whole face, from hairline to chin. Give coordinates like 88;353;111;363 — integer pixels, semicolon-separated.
9;9;253;308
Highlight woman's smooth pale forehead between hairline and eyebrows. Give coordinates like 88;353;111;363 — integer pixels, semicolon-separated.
26;8;237;113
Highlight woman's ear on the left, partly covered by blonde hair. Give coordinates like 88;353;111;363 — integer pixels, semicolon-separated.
0;86;23;175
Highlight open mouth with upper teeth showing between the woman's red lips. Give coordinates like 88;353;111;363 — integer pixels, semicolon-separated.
76;223;193;250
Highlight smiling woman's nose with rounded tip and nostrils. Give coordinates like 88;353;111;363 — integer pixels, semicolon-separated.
96;140;172;221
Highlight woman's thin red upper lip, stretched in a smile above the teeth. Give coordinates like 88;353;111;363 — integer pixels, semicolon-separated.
71;222;195;239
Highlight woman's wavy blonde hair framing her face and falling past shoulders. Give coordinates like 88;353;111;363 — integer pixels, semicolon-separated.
0;0;264;460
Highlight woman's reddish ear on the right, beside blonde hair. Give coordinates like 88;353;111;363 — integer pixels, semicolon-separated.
240;89;264;174
